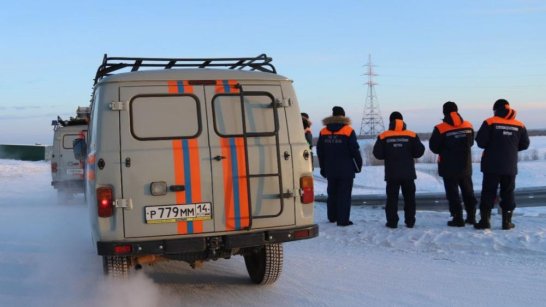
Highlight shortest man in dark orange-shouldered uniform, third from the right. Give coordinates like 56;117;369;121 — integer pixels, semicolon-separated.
373;112;425;228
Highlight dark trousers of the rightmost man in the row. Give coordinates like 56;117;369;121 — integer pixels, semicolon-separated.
480;173;516;212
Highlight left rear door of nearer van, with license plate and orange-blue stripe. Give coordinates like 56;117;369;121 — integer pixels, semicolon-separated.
119;81;214;237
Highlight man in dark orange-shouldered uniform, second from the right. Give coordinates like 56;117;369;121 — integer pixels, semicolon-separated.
429;101;477;227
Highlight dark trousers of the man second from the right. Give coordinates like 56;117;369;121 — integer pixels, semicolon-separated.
444;176;478;216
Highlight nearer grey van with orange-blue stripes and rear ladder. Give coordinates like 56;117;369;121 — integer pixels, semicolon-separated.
87;55;318;284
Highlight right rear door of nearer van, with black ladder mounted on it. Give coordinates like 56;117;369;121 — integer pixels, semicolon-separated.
205;80;295;231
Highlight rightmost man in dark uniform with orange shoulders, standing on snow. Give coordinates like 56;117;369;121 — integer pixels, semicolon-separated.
474;99;529;230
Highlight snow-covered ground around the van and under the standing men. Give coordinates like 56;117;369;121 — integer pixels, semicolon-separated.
0;160;546;307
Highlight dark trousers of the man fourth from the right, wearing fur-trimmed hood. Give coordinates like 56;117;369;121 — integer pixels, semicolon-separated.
326;178;354;225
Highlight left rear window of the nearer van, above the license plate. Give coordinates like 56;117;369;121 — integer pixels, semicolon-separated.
129;94;201;141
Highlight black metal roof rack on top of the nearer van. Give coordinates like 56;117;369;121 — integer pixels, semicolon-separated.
94;53;277;84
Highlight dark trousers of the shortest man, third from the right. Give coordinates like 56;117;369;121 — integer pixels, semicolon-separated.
385;179;415;226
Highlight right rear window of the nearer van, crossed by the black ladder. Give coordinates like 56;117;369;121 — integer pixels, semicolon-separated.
212;92;278;137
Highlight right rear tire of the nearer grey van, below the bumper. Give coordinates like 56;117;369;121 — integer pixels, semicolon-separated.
244;243;283;285
